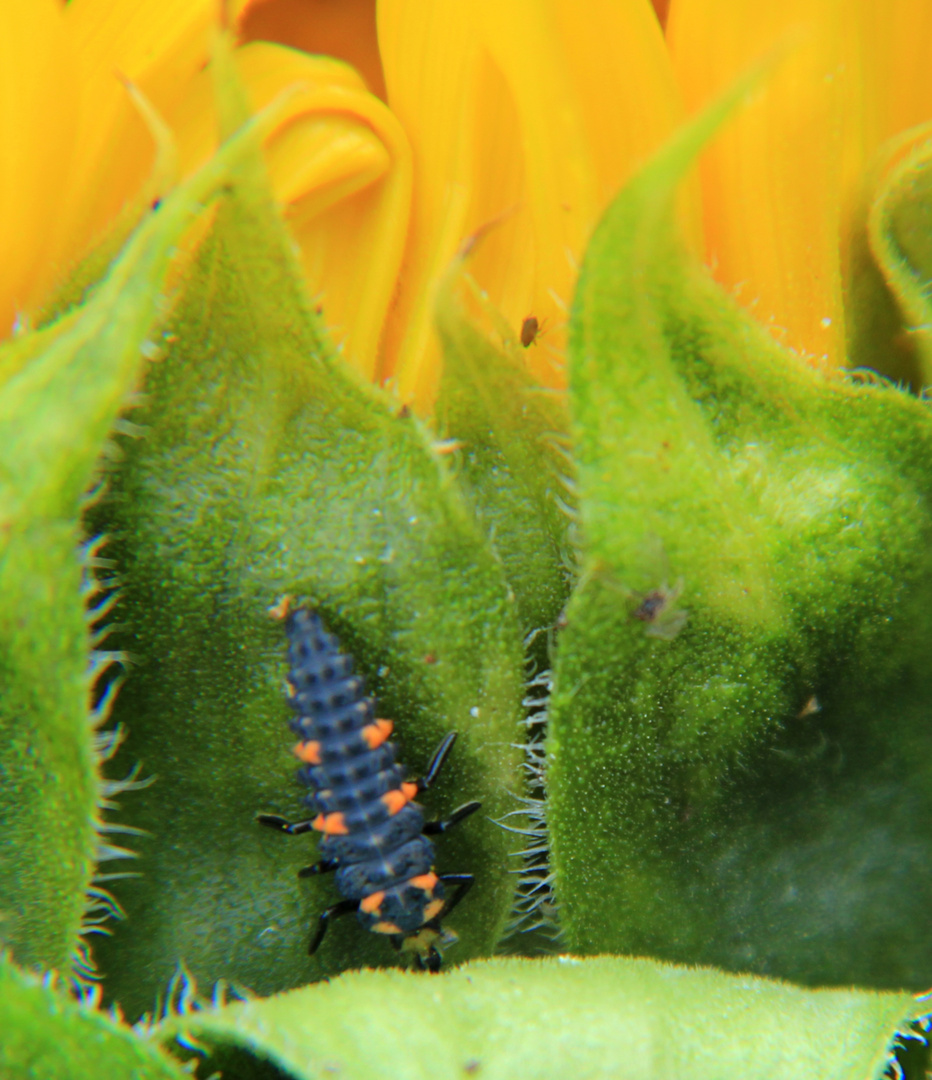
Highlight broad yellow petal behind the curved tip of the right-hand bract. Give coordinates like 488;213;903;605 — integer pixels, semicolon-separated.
667;0;861;367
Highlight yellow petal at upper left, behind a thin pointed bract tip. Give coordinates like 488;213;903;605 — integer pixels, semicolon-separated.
56;0;216;267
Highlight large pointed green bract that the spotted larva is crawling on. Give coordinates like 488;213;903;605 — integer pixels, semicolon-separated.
92;50;523;1014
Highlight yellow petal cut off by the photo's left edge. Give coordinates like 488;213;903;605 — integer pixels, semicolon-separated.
0;0;76;338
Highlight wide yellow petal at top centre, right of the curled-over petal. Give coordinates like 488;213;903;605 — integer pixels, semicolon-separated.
379;0;679;410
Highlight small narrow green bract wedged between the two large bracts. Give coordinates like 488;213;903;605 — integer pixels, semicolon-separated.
436;259;573;634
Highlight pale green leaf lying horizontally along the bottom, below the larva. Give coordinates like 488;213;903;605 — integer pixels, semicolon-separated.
154;957;917;1080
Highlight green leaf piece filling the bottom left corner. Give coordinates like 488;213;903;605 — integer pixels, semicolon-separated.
0;957;188;1080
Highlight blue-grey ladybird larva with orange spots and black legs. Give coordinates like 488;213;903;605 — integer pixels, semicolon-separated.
258;597;481;971
